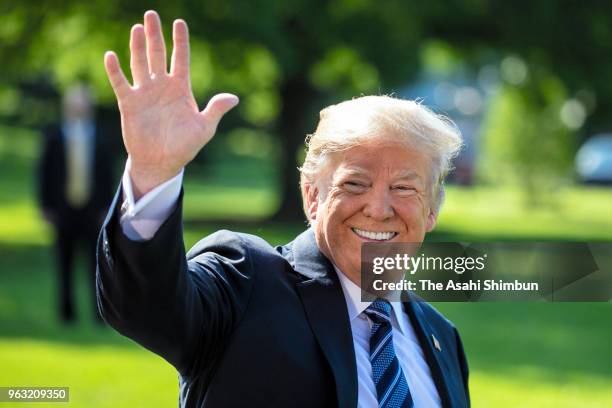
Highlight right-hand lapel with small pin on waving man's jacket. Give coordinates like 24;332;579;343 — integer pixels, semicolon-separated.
404;299;457;407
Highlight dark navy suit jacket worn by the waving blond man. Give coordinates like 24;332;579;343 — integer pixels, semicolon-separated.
97;186;469;408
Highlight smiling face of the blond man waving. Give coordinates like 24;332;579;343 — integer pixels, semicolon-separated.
305;142;436;285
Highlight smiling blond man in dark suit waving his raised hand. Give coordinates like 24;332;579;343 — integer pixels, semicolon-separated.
98;11;469;407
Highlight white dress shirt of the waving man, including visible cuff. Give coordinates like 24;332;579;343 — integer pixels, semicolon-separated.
120;166;440;408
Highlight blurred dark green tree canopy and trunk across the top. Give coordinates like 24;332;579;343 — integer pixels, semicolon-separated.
0;0;612;219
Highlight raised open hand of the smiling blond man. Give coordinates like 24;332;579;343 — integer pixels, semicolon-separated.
104;11;238;199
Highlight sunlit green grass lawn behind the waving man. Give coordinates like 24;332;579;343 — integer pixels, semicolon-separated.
0;128;612;408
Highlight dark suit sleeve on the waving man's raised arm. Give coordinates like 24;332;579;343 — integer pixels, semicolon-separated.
96;185;255;376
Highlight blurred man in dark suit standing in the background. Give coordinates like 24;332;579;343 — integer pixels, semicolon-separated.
38;84;113;323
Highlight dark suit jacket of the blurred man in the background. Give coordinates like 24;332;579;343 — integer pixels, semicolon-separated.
38;125;113;222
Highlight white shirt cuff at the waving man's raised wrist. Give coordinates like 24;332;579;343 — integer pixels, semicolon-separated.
119;159;185;241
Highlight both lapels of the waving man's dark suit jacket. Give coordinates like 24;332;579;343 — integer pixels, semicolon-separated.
284;229;461;408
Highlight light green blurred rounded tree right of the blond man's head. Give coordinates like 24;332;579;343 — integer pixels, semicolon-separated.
481;68;576;204
